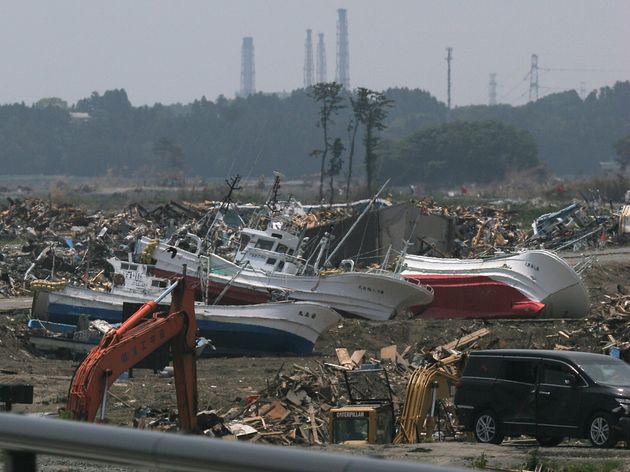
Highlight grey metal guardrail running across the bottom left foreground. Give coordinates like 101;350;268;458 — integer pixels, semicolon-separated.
0;413;465;472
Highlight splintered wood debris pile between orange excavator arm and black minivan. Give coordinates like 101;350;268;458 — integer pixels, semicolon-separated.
134;328;490;445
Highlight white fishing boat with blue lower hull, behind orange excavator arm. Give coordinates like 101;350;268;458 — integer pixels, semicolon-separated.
32;258;341;356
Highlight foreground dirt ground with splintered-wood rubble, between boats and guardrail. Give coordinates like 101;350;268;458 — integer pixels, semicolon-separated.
0;252;630;471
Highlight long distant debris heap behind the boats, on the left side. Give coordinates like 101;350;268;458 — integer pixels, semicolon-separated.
0;198;366;297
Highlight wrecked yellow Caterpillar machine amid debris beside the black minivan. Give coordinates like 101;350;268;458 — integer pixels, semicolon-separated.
329;354;461;445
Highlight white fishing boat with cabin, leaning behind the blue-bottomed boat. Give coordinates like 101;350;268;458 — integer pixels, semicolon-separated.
136;232;433;320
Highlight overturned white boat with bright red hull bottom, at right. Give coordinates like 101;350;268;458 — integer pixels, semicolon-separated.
402;250;589;318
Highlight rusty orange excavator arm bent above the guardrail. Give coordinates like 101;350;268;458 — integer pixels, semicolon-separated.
67;279;197;432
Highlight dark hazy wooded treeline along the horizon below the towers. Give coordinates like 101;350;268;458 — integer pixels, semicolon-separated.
0;82;630;183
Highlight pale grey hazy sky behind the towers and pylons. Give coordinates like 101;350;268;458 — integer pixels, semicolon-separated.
0;0;630;106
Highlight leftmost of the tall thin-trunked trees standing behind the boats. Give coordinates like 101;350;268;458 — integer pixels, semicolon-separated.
309;82;345;201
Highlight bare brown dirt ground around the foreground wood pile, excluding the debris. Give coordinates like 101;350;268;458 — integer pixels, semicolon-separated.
0;252;630;472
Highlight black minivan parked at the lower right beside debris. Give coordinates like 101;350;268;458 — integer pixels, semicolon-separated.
455;349;630;447
